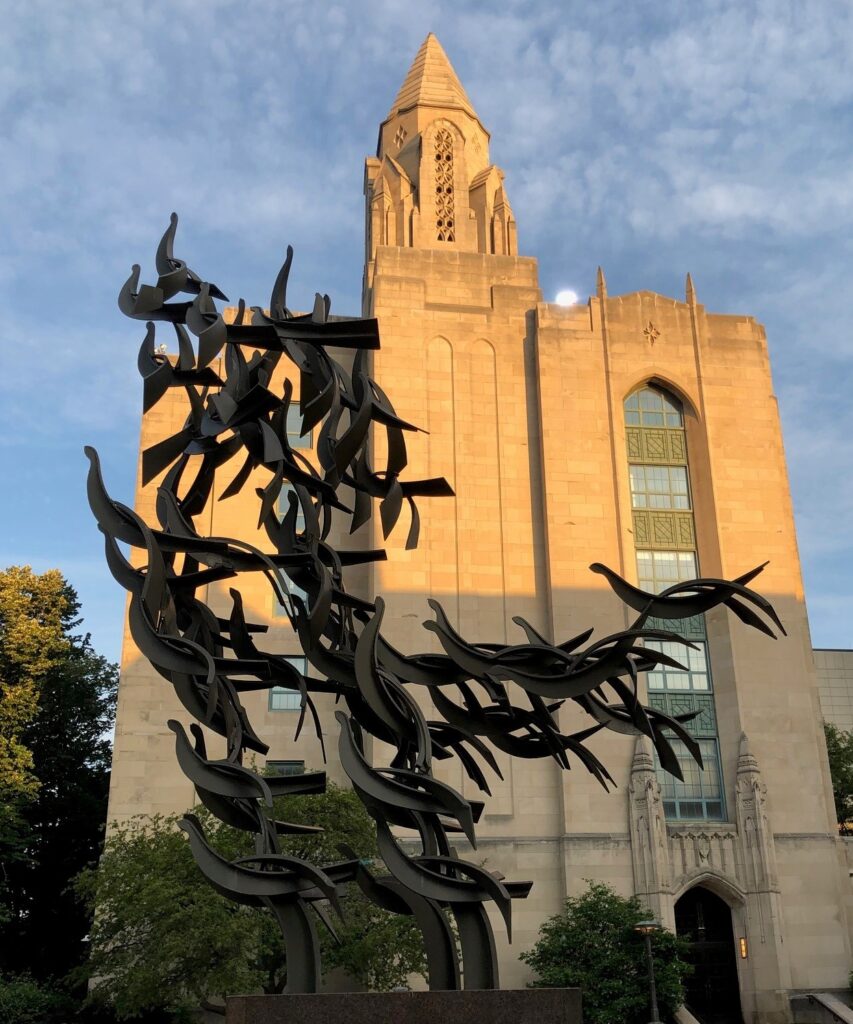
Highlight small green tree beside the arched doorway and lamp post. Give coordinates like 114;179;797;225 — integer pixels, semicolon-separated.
521;882;690;1024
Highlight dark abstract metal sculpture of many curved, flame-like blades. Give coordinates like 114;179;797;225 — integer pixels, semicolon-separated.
86;214;781;992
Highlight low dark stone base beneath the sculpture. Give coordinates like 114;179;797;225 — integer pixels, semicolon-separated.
225;988;583;1024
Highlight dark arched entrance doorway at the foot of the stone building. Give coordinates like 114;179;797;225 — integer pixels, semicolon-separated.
675;886;743;1024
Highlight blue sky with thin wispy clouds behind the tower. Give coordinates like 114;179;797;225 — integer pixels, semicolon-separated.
0;0;853;658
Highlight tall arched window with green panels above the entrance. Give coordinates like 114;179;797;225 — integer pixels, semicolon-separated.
625;384;725;819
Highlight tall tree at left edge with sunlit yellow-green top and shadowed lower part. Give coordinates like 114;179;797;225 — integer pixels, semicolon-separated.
0;566;117;991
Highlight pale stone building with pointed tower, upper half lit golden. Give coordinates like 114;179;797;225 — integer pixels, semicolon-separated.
110;35;851;1022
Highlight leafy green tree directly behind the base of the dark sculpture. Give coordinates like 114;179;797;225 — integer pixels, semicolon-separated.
76;783;425;1018
